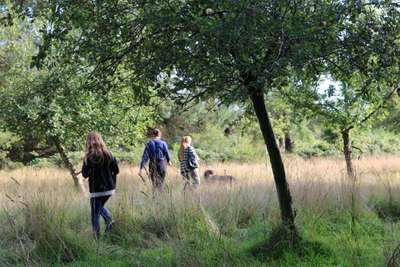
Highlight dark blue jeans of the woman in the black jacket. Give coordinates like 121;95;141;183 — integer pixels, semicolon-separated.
90;196;112;238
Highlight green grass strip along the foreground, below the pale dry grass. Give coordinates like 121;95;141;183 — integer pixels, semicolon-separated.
0;197;400;266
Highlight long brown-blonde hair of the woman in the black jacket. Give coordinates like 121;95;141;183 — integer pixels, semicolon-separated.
85;132;112;162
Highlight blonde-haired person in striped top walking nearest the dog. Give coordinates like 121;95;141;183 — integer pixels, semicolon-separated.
178;136;200;189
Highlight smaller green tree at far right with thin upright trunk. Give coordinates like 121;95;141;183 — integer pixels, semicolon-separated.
283;2;400;177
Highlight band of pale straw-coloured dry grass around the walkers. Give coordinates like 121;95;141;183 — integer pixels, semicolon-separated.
0;156;400;218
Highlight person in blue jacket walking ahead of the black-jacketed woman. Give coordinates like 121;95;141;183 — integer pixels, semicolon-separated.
139;129;172;191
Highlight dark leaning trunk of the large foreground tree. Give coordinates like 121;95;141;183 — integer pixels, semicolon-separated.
249;88;297;236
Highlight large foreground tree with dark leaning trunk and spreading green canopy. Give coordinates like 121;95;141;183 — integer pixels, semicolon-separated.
17;0;397;241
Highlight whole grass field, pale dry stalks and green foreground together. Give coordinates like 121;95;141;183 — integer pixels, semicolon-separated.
0;156;400;266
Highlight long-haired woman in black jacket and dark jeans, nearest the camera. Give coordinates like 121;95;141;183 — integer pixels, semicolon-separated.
82;132;119;238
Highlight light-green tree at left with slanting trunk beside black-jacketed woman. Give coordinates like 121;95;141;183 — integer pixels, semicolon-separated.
0;9;152;191
